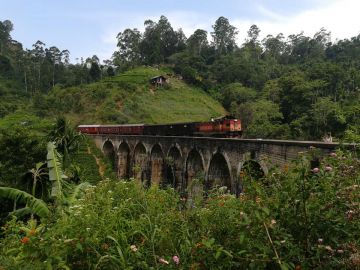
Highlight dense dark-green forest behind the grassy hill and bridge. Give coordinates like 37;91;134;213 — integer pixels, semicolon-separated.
0;16;360;141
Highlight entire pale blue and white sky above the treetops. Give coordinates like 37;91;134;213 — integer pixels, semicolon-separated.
0;0;360;63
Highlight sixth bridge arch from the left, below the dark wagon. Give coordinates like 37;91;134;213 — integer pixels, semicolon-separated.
184;148;205;195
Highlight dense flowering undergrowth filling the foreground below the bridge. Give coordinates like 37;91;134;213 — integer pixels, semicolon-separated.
0;151;360;269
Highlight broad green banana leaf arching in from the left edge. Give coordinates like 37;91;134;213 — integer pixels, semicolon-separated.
0;187;49;217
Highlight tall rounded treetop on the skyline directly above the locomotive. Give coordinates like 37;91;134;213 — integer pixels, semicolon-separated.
211;17;238;55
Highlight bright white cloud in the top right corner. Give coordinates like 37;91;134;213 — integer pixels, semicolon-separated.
233;0;360;44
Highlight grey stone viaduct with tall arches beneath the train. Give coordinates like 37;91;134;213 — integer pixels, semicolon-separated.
91;134;338;194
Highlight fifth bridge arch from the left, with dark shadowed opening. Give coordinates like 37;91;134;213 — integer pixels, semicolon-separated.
164;145;183;190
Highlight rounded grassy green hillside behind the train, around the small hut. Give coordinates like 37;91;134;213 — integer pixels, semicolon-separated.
47;67;226;124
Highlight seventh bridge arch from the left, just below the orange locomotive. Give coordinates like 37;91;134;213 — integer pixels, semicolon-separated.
206;152;232;191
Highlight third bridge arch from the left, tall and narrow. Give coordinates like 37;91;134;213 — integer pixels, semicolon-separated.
133;142;150;186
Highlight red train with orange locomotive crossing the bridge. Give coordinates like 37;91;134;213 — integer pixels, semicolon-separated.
78;116;242;138
